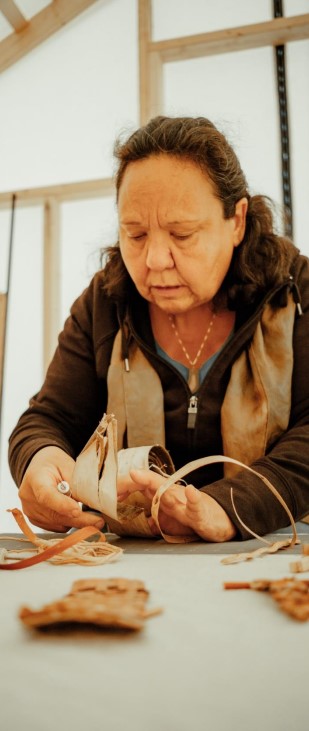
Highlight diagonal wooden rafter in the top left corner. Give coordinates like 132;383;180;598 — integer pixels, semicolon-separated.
0;0;97;73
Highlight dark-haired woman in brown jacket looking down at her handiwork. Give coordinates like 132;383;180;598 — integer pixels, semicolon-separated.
10;117;309;541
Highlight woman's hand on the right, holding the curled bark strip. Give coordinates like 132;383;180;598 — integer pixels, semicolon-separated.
118;470;236;543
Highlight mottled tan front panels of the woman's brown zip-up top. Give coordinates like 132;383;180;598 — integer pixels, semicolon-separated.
107;294;295;477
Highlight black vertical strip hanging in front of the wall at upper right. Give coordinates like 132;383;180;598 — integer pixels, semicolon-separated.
273;0;293;238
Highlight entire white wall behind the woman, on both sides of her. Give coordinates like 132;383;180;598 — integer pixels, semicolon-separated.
0;0;309;531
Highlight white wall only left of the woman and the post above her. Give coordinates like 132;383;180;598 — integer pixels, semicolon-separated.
0;0;138;530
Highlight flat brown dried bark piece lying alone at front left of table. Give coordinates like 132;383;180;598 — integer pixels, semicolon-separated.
19;578;162;630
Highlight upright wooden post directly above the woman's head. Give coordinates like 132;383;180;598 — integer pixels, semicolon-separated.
138;0;163;124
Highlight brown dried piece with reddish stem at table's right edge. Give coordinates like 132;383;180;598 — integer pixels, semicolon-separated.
224;578;309;622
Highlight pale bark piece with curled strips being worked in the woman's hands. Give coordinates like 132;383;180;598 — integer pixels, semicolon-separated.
71;414;298;552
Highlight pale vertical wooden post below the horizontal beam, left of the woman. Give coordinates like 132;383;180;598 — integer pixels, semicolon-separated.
43;198;61;371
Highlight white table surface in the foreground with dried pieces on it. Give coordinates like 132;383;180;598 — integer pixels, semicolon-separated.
0;526;309;731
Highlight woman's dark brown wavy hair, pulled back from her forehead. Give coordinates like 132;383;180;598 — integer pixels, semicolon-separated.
105;116;297;307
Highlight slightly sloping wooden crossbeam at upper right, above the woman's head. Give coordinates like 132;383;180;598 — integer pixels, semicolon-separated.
147;13;309;62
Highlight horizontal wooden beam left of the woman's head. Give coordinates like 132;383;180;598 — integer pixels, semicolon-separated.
0;178;115;210
